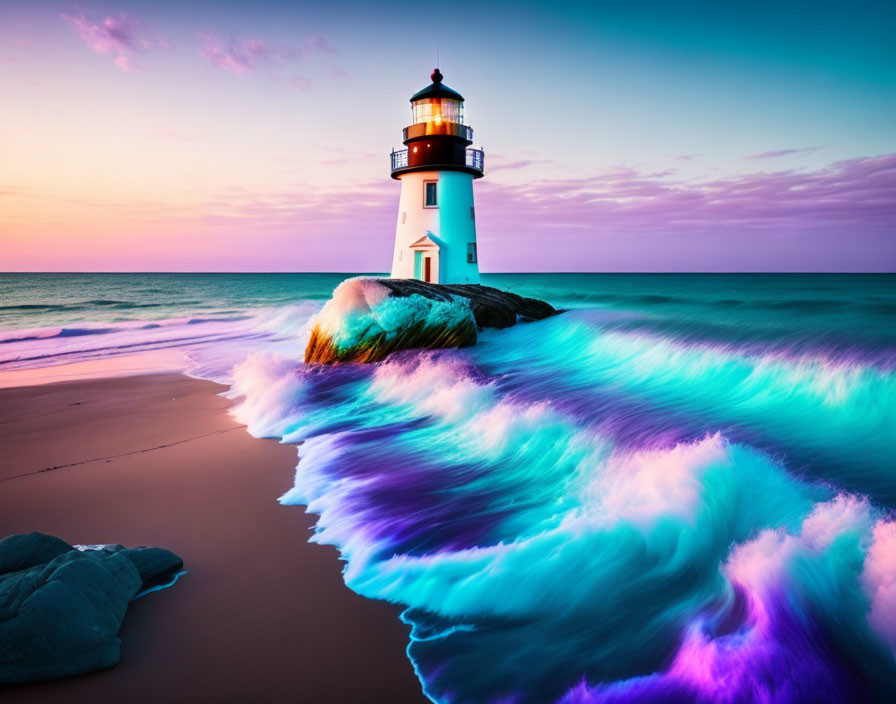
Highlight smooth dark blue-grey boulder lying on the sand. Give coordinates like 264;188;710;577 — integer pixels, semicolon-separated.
0;533;183;684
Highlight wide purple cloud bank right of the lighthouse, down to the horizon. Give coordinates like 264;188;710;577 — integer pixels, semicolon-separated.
466;154;896;271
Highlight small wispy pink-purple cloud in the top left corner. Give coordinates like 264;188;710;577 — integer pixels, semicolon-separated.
62;7;168;73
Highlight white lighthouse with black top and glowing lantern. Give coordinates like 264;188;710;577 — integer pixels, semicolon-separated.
392;69;484;284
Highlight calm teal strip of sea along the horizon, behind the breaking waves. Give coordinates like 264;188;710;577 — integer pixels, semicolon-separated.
0;274;896;358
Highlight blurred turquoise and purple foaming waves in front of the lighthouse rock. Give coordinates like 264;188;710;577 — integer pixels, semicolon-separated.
233;314;896;702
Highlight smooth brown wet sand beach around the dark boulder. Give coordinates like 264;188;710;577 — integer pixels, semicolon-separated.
0;374;427;703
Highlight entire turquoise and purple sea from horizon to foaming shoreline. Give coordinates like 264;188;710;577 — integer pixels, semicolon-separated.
0;274;896;703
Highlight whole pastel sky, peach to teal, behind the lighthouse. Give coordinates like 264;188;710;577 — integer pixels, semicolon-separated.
0;0;896;272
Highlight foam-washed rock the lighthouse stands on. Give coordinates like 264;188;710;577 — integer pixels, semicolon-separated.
305;277;558;364
